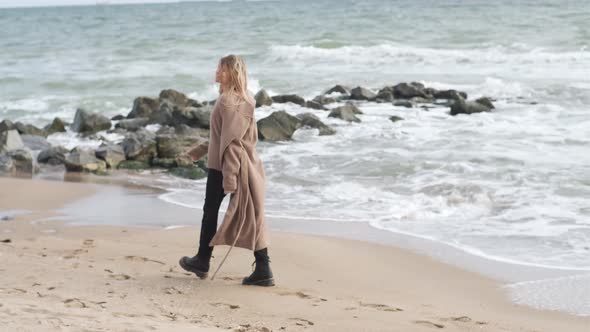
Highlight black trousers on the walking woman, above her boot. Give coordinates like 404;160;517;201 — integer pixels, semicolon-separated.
197;168;226;260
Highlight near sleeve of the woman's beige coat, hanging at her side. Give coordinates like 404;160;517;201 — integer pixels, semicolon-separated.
219;95;248;194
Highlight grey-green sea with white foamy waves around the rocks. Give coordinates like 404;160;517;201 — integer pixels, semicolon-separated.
0;0;590;315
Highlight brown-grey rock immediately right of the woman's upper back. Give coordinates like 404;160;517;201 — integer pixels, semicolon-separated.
257;111;301;141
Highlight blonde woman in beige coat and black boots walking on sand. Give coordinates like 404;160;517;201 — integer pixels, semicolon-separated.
180;55;274;286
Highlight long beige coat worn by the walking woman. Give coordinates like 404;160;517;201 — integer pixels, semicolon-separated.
189;93;269;250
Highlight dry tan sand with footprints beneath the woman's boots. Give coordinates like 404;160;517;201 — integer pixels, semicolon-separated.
0;178;590;332
